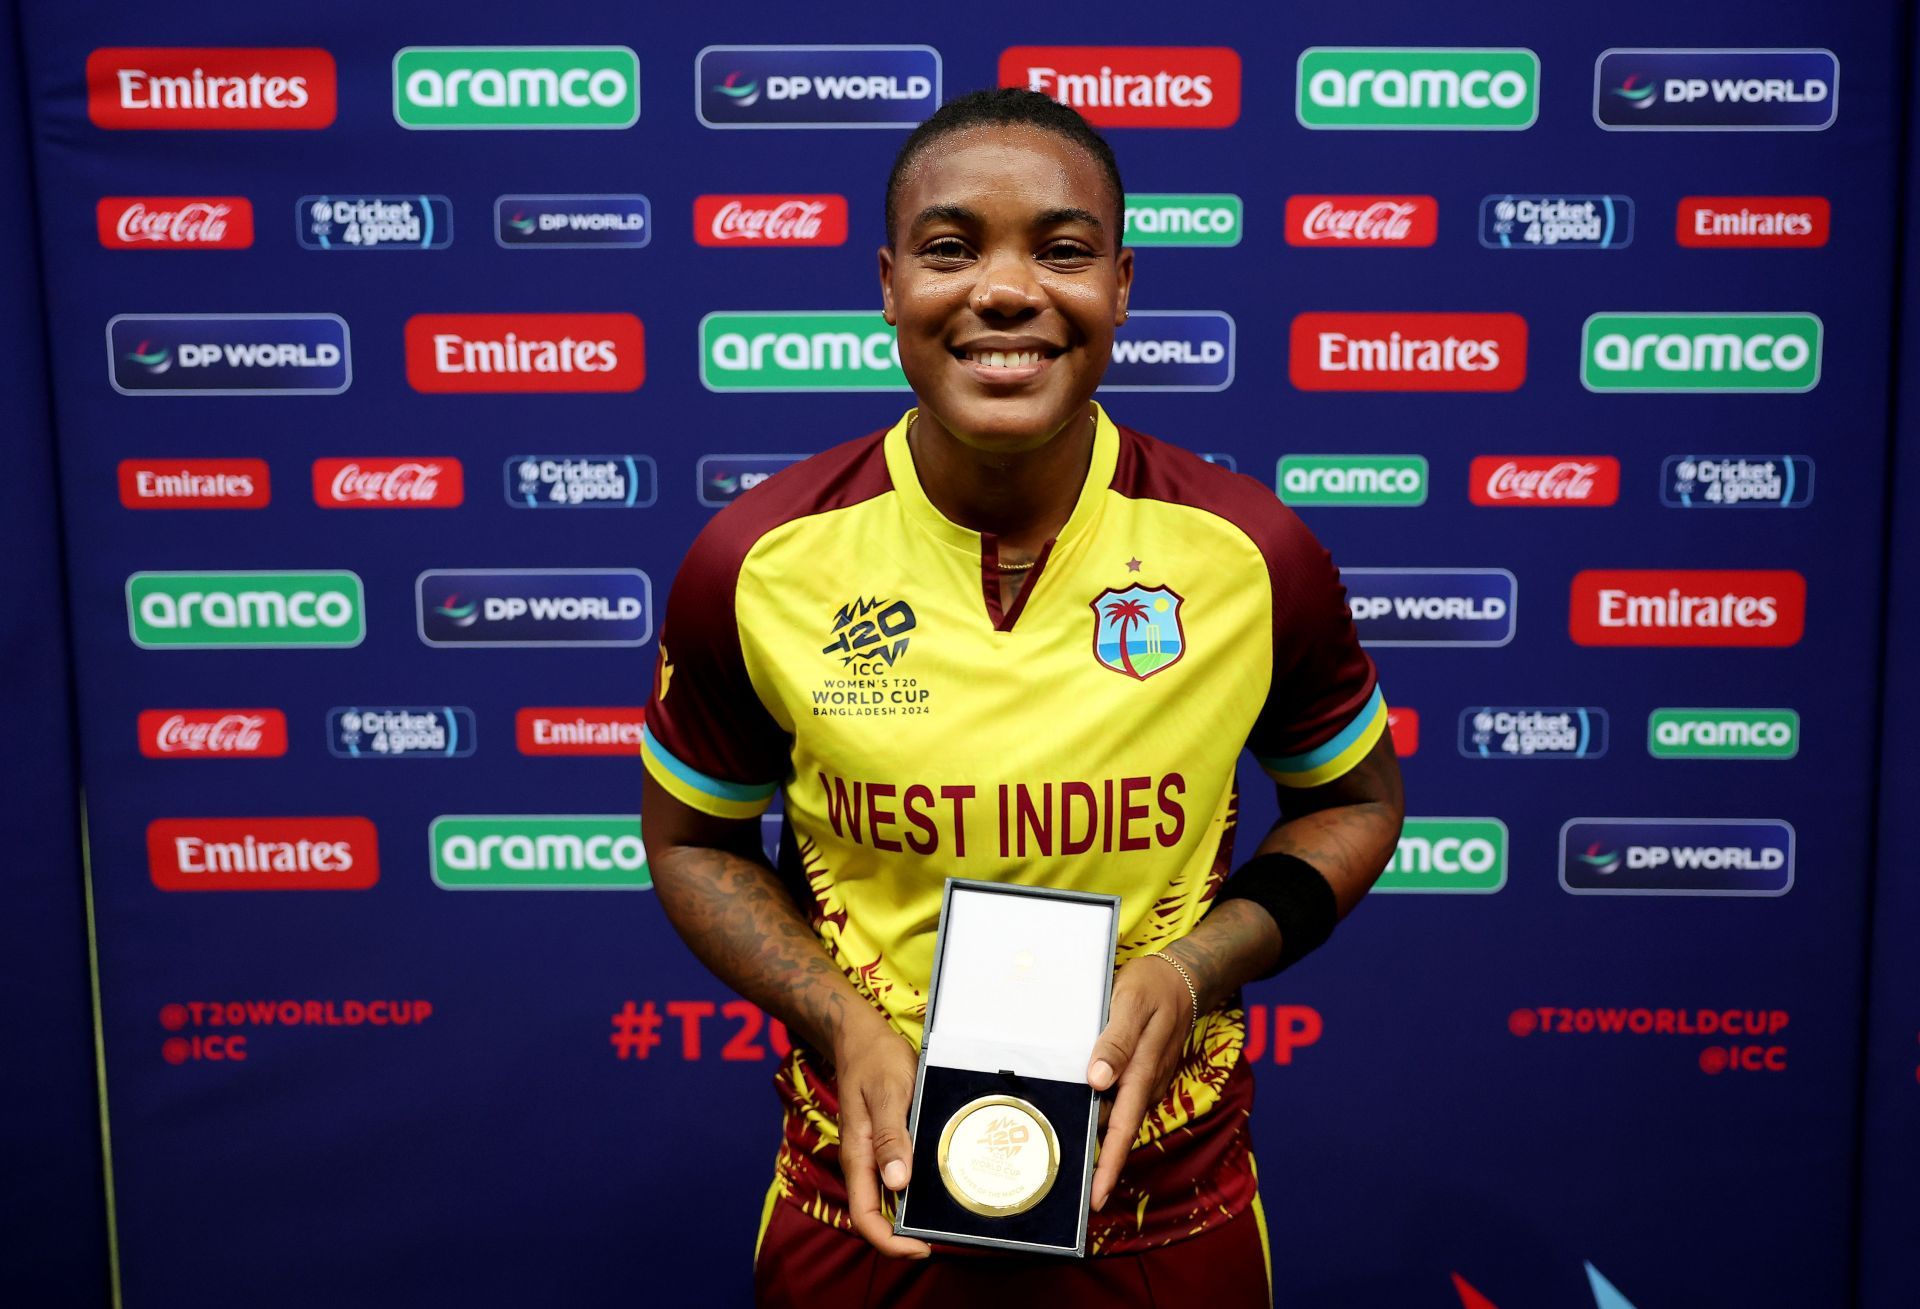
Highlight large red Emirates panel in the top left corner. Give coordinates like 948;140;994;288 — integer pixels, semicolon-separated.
86;46;336;131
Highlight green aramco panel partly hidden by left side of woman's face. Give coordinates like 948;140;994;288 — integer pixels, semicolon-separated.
701;309;908;392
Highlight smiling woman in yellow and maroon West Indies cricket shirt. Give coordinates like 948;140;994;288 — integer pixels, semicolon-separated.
643;90;1402;1307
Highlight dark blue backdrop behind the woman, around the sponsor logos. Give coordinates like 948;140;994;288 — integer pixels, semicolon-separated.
7;0;1914;1309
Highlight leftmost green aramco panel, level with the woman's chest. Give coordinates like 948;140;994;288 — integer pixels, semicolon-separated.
127;572;367;649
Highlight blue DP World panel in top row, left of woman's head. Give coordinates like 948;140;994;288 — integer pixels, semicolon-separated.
693;46;941;129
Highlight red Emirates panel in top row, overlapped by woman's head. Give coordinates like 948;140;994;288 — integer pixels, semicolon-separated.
1000;46;1240;127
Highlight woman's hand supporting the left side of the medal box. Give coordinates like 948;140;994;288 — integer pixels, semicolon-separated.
833;1005;933;1259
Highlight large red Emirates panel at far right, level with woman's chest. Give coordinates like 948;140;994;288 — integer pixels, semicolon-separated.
1567;568;1807;647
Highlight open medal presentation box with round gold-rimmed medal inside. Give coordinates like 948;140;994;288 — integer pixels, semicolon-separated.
893;877;1119;1255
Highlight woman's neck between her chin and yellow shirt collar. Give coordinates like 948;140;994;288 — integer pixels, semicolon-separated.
908;405;1094;553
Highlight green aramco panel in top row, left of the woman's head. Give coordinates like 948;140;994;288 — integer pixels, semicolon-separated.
394;46;639;131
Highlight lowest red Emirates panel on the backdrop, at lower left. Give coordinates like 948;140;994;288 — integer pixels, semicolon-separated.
146;818;380;891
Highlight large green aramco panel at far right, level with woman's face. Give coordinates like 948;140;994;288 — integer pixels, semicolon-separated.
1580;313;1822;392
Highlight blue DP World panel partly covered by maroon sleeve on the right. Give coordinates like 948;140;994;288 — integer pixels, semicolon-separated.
1340;568;1519;645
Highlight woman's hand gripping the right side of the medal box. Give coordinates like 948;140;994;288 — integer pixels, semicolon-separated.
1087;956;1194;1209
